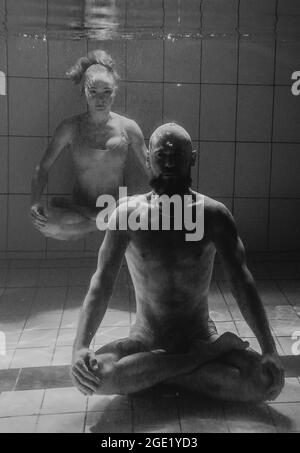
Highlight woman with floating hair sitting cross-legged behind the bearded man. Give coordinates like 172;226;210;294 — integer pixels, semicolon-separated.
31;50;147;241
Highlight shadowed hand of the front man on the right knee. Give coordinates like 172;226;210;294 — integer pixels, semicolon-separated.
262;353;285;401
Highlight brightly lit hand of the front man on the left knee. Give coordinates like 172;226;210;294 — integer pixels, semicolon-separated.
71;349;100;396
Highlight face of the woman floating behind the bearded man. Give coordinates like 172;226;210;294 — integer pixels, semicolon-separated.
84;74;117;112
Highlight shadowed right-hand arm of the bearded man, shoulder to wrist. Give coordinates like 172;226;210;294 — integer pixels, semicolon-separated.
213;204;277;354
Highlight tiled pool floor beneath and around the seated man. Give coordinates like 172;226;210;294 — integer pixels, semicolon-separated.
0;260;300;433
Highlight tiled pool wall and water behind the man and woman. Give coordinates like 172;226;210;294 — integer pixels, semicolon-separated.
0;0;300;258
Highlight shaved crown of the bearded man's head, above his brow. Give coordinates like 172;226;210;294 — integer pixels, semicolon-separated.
149;123;192;152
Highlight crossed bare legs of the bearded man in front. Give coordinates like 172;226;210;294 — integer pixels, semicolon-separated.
91;333;271;402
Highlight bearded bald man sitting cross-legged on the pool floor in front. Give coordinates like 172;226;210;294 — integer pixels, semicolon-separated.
71;124;284;402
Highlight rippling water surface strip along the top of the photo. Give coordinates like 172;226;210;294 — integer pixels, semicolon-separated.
0;0;300;40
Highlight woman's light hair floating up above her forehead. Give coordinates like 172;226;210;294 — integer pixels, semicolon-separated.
67;50;119;83
